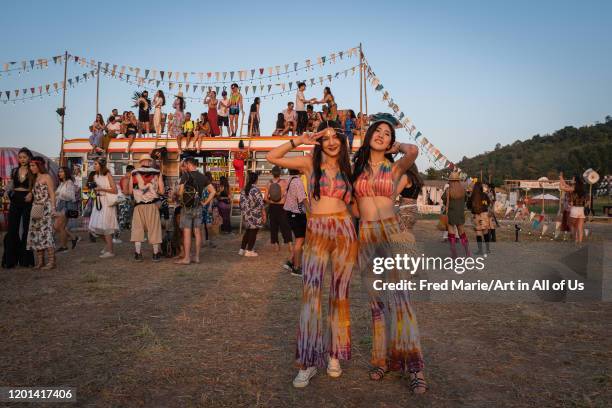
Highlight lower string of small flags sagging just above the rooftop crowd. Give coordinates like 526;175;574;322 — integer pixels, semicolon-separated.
93;61;359;101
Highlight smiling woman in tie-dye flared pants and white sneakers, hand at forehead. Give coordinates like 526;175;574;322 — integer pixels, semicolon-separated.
267;121;358;388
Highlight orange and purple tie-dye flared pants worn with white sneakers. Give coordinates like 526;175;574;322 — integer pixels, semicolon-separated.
296;213;358;368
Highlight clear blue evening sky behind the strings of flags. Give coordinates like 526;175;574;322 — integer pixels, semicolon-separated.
0;0;612;167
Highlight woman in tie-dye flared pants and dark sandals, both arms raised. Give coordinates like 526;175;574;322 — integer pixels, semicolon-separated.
353;114;427;393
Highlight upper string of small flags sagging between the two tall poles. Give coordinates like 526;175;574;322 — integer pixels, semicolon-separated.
68;47;359;86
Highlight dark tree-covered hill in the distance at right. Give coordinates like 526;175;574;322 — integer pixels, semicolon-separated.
457;116;612;185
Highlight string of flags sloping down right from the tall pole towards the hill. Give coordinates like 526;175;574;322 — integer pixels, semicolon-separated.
363;57;467;179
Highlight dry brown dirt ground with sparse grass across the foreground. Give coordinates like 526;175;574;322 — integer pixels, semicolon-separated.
0;222;612;407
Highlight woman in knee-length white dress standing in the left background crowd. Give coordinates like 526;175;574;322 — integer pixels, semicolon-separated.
88;157;119;258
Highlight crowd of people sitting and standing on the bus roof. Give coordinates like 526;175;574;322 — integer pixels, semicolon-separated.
89;82;366;155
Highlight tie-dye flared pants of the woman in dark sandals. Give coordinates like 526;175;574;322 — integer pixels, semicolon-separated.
359;217;424;372
